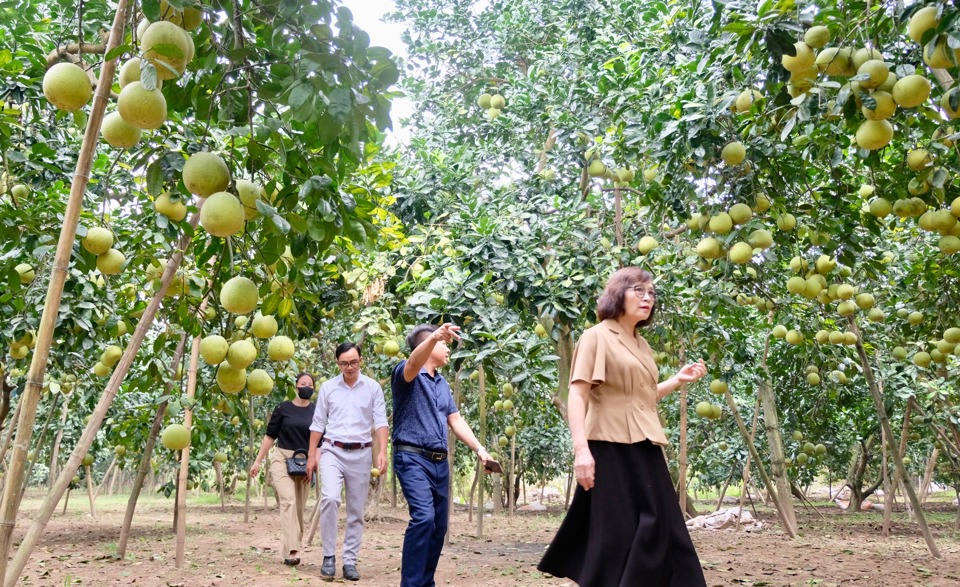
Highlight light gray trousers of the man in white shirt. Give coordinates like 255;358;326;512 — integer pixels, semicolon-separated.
320;442;373;565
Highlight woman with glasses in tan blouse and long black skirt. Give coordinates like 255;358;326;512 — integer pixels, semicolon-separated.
537;267;707;587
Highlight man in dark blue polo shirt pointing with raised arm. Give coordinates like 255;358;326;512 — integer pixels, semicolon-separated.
391;323;490;587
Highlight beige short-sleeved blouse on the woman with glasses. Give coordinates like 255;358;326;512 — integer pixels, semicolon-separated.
570;319;667;445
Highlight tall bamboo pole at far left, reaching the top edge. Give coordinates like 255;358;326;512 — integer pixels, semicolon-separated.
0;0;127;586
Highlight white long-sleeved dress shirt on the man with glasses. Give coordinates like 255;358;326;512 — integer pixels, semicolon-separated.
310;374;387;442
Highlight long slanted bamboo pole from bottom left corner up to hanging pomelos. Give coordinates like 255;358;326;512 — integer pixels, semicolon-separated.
4;235;200;587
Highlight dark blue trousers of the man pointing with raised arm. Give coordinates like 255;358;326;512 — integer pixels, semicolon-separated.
393;451;450;587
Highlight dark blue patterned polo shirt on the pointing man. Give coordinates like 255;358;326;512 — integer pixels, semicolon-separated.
391;361;459;452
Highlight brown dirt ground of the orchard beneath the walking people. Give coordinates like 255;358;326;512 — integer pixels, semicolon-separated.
7;494;960;587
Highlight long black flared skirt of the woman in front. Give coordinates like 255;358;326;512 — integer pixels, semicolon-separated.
537;440;706;587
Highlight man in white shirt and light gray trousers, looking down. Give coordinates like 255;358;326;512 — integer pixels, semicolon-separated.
307;342;387;581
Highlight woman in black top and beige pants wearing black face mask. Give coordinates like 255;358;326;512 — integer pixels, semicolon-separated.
250;373;320;566
